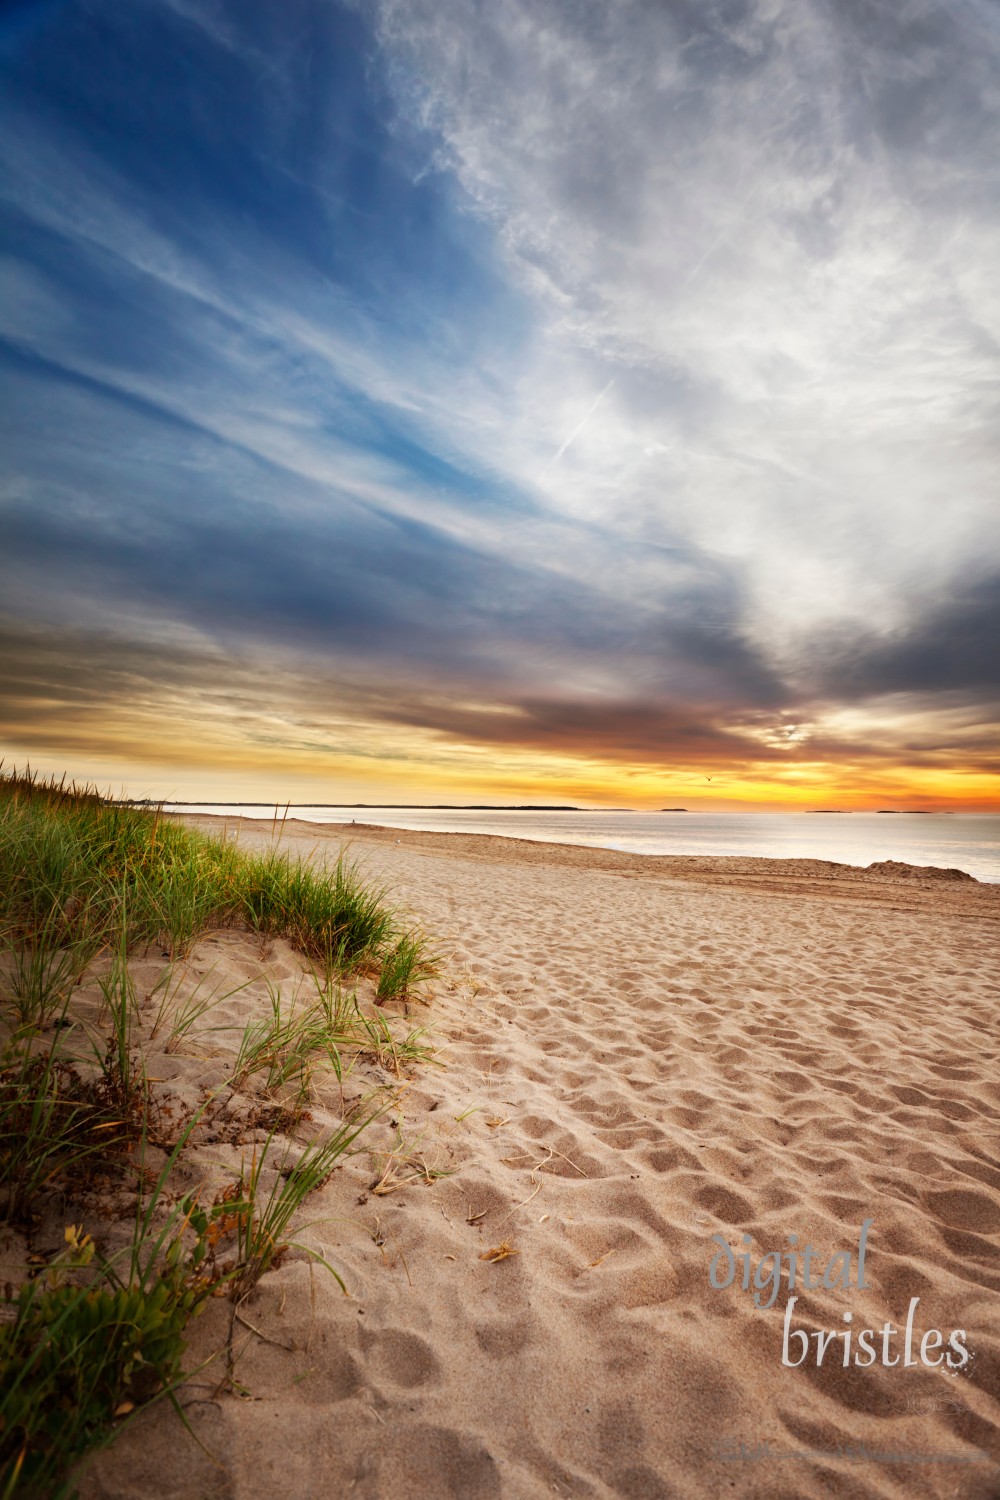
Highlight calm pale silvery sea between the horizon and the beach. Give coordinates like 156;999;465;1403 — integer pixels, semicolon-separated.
168;803;1000;882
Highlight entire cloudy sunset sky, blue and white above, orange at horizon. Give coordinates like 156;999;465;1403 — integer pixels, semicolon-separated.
0;0;1000;810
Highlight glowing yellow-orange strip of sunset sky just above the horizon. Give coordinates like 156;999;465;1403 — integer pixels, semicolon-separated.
0;726;1000;812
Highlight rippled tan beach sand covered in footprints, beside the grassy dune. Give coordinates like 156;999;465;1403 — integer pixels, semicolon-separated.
82;818;1000;1500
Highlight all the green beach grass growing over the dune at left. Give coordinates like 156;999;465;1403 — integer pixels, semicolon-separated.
0;773;435;1500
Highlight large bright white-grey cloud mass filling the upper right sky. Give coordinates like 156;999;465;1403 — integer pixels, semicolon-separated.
371;0;1000;650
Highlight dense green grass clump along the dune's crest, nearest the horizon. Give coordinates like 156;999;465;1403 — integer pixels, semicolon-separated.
0;773;430;978
